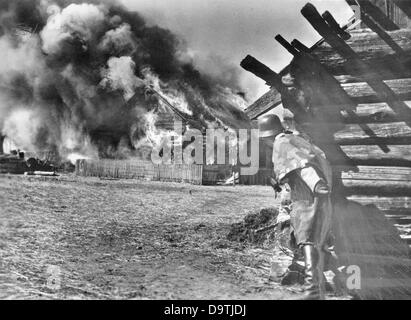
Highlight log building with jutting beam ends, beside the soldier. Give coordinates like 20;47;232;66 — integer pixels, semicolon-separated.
241;0;411;300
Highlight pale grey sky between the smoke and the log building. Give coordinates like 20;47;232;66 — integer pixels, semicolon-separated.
121;0;353;102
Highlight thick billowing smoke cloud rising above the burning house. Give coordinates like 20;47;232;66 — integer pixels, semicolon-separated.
0;0;249;159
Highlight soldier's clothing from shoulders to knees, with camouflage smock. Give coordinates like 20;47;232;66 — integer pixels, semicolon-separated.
273;132;332;248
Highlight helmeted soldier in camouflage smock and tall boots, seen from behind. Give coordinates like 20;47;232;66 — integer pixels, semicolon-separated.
258;114;332;299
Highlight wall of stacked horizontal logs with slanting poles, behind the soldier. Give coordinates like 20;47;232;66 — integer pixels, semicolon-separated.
296;6;411;251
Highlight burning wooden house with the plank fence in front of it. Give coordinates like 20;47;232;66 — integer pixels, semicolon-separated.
76;87;238;184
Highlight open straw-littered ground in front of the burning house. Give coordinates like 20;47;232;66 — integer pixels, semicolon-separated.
0;175;316;299
